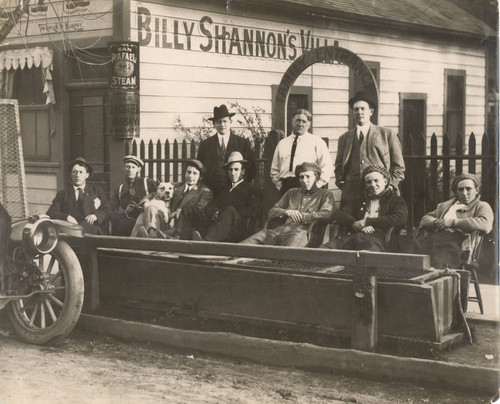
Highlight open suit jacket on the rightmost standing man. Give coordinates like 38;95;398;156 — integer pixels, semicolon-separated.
335;124;405;188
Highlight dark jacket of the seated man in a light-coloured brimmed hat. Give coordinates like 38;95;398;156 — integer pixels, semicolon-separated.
206;181;262;218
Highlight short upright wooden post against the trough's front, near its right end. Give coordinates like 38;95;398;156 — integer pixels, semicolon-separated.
351;252;378;351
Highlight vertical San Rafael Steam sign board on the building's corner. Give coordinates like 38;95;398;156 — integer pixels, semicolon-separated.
108;41;140;139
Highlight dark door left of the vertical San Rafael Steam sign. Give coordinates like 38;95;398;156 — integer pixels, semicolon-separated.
69;88;110;193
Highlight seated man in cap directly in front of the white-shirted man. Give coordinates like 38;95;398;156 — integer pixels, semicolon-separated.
242;162;333;247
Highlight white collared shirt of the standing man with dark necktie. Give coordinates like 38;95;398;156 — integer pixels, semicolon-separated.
271;133;333;187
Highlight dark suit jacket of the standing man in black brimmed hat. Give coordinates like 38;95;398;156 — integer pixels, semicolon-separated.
197;133;255;191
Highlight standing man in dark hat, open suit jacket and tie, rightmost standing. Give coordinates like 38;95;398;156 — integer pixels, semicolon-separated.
335;91;405;213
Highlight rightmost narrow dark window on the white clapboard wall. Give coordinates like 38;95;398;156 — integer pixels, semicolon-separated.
443;69;465;150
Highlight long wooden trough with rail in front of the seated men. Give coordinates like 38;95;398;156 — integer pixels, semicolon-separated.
81;236;465;350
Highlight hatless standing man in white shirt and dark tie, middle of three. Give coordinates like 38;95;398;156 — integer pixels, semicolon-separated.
271;109;332;196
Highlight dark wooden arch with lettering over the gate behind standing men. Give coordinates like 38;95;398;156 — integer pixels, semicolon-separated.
273;46;378;133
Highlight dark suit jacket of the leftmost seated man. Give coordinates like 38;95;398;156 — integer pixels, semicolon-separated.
47;185;111;224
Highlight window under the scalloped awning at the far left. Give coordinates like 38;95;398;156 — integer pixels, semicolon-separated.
2;66;51;159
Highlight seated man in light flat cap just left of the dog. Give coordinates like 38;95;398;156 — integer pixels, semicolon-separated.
109;155;158;236
